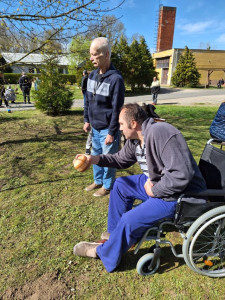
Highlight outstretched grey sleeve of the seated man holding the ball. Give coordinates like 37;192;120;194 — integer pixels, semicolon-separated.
98;140;137;169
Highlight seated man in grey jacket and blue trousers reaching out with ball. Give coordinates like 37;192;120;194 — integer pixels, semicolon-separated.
73;103;206;272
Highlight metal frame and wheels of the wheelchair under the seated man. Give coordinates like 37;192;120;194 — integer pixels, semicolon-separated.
134;139;225;277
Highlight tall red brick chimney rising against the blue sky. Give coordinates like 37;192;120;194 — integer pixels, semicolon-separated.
156;6;176;52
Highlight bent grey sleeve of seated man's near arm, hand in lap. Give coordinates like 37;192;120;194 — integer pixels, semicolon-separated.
149;134;195;198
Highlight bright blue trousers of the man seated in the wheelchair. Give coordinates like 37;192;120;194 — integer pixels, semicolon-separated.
96;174;176;272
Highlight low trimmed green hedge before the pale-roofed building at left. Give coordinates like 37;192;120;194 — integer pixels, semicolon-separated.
4;73;76;84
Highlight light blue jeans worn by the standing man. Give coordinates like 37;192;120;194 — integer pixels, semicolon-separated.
91;128;120;190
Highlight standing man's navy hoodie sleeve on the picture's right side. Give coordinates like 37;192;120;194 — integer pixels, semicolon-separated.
109;76;125;136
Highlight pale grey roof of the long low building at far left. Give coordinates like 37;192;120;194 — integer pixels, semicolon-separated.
1;52;69;66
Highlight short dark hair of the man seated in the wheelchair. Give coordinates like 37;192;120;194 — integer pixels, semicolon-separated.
121;103;148;128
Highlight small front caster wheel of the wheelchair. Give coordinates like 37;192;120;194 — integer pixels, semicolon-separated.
136;253;160;276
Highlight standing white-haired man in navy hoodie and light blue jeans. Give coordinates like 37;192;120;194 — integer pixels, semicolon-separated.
83;37;125;197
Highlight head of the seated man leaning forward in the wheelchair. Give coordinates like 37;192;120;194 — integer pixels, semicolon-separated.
119;103;148;139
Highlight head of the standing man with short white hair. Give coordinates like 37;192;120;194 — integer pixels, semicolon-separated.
90;37;111;73
